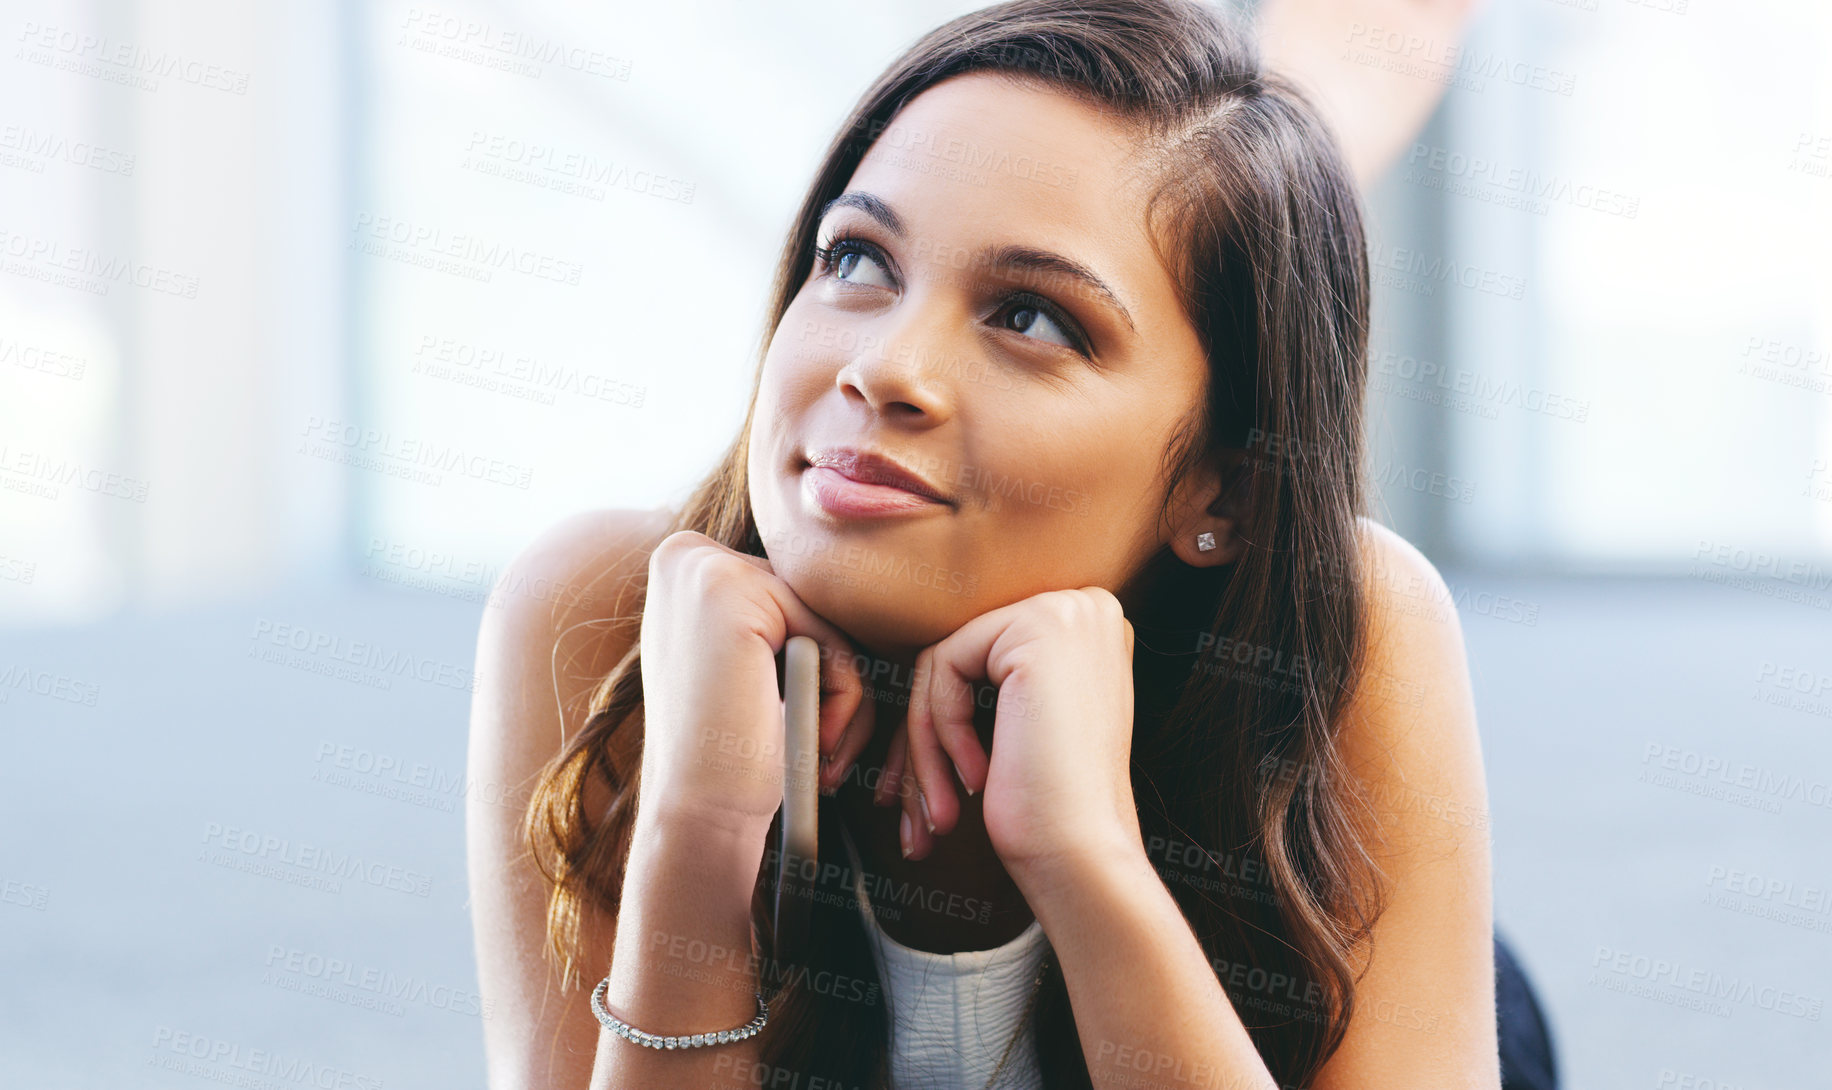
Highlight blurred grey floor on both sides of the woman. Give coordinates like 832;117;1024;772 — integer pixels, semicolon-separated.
0;572;1832;1090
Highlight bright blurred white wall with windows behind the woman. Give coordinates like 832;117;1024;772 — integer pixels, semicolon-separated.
0;0;1832;625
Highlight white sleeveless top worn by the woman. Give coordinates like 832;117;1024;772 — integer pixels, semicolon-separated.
841;826;1050;1090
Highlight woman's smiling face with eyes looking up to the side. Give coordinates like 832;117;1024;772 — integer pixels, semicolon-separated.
749;73;1207;654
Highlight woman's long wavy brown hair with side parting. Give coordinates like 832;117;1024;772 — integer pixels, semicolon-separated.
526;0;1379;1086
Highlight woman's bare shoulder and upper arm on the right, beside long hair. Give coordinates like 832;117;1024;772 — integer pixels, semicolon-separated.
1312;534;1499;1090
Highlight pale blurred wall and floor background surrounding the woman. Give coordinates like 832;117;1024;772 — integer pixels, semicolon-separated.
0;0;1832;1090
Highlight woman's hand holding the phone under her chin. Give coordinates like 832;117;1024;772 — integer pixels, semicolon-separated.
639;529;872;837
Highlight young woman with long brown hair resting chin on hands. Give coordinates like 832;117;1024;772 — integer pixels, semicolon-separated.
467;0;1553;1090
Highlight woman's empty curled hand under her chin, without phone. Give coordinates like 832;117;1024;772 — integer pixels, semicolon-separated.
876;586;1140;874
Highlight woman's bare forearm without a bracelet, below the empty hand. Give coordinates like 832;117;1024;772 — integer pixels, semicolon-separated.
1013;843;1277;1090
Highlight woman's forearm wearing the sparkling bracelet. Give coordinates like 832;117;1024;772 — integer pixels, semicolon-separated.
592;808;768;1090
